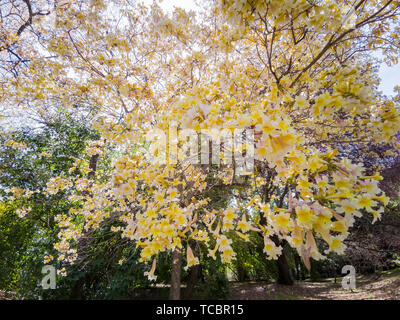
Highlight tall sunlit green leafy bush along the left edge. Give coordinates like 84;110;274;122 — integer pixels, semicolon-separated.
0;118;98;298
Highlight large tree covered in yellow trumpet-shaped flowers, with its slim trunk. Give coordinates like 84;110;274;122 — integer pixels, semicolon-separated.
0;0;400;298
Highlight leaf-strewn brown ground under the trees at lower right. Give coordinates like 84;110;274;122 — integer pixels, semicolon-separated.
231;269;400;300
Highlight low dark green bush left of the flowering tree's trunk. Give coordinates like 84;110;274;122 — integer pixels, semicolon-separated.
42;230;155;299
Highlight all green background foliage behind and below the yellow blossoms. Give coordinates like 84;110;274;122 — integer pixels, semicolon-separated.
0;111;400;299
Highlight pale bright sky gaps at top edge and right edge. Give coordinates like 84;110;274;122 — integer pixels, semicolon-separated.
148;0;400;96
